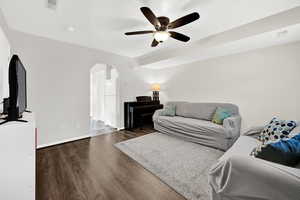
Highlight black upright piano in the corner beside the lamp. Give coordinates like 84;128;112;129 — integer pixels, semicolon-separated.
124;97;163;130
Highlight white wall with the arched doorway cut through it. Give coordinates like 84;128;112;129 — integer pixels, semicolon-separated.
11;31;150;146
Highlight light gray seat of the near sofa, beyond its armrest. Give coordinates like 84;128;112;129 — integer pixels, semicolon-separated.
219;135;260;160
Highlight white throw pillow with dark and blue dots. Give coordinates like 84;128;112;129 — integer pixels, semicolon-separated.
258;117;297;144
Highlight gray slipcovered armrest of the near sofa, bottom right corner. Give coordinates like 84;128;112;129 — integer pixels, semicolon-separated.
209;155;300;200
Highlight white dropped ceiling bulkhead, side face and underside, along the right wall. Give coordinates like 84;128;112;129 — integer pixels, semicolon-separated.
136;6;300;69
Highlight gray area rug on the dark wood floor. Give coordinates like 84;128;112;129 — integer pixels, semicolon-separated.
115;132;223;200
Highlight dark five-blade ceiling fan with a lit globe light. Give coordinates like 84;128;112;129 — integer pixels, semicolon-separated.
125;7;200;47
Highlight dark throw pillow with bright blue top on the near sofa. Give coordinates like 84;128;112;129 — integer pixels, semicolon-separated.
252;134;300;167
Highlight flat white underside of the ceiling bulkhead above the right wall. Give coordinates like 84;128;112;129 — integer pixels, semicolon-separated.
143;24;300;69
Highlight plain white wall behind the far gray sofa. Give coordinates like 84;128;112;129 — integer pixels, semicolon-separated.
154;42;300;128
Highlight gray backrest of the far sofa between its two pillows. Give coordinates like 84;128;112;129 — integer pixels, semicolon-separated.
176;102;239;121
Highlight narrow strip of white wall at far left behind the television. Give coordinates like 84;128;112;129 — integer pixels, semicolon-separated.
0;18;10;101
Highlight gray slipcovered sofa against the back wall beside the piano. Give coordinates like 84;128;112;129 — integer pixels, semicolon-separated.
153;102;241;150
